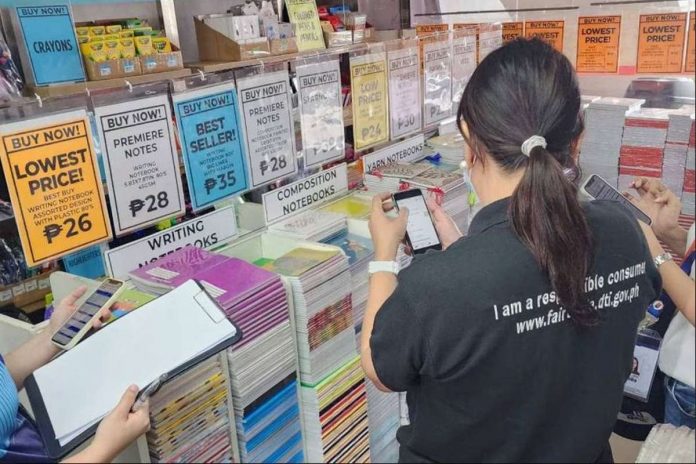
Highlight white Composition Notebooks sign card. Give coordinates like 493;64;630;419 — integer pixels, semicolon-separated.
262;163;348;224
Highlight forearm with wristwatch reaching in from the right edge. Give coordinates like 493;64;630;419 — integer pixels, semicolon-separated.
639;221;696;325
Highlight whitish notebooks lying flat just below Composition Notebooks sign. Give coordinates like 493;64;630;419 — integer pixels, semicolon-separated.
268;210;348;243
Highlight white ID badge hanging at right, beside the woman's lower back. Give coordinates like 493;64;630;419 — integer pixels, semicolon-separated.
624;329;662;403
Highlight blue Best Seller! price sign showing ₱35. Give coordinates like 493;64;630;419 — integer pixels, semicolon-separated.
173;83;247;211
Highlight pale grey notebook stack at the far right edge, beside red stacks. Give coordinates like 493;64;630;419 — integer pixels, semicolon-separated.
662;106;694;196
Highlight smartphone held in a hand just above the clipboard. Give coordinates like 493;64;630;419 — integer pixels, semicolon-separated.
51;279;123;350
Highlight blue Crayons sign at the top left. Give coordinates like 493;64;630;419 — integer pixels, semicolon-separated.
16;2;85;85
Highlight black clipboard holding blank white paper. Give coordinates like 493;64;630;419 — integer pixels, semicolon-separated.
25;280;242;459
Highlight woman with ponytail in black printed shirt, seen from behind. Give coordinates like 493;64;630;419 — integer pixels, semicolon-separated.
361;39;660;462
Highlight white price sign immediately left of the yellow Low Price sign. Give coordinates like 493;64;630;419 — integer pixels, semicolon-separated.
297;60;345;167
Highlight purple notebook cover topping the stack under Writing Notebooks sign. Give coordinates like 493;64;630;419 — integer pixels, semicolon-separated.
130;246;230;289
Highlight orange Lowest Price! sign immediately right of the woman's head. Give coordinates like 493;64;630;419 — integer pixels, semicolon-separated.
575;16;621;73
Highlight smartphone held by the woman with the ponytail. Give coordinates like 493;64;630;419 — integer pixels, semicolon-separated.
392;189;442;254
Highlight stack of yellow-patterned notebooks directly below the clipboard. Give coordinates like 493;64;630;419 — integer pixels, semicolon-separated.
146;356;234;462
